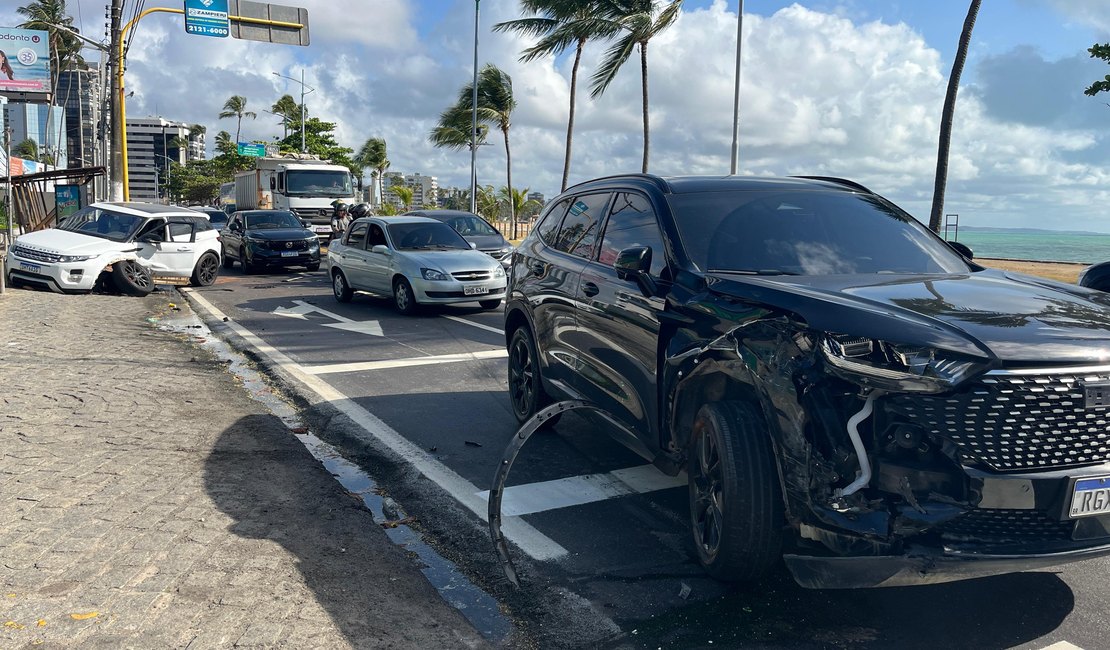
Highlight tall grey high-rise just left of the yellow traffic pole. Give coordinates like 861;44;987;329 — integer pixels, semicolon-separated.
54;64;104;167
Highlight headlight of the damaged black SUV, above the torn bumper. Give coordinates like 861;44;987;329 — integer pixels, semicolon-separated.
821;334;986;393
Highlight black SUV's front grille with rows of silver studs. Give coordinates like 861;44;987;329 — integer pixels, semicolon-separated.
887;368;1110;470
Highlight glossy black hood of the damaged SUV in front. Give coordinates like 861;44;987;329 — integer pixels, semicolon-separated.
707;270;1110;365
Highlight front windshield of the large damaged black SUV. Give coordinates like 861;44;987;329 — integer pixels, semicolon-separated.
668;191;970;275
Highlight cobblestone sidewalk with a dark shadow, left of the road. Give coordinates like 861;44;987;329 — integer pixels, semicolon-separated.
0;290;485;648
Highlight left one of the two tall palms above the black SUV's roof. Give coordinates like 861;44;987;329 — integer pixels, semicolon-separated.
493;0;617;191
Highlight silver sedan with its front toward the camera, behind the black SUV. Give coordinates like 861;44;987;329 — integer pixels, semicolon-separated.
327;216;505;314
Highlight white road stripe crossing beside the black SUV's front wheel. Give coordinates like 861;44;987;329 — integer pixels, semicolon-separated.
477;465;686;517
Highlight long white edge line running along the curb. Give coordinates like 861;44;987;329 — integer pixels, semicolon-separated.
181;287;567;560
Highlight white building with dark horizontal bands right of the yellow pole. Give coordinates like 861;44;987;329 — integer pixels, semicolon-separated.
128;118;195;201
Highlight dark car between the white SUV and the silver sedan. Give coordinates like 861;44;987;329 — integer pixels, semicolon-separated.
223;210;320;274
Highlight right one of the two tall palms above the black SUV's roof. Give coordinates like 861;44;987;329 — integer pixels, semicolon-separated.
589;0;683;173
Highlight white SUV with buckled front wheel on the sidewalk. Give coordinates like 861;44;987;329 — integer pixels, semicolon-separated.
4;202;220;295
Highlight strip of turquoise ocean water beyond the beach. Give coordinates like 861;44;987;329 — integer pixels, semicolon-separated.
948;230;1110;264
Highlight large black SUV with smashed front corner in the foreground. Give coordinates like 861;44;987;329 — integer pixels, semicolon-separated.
505;174;1110;588
